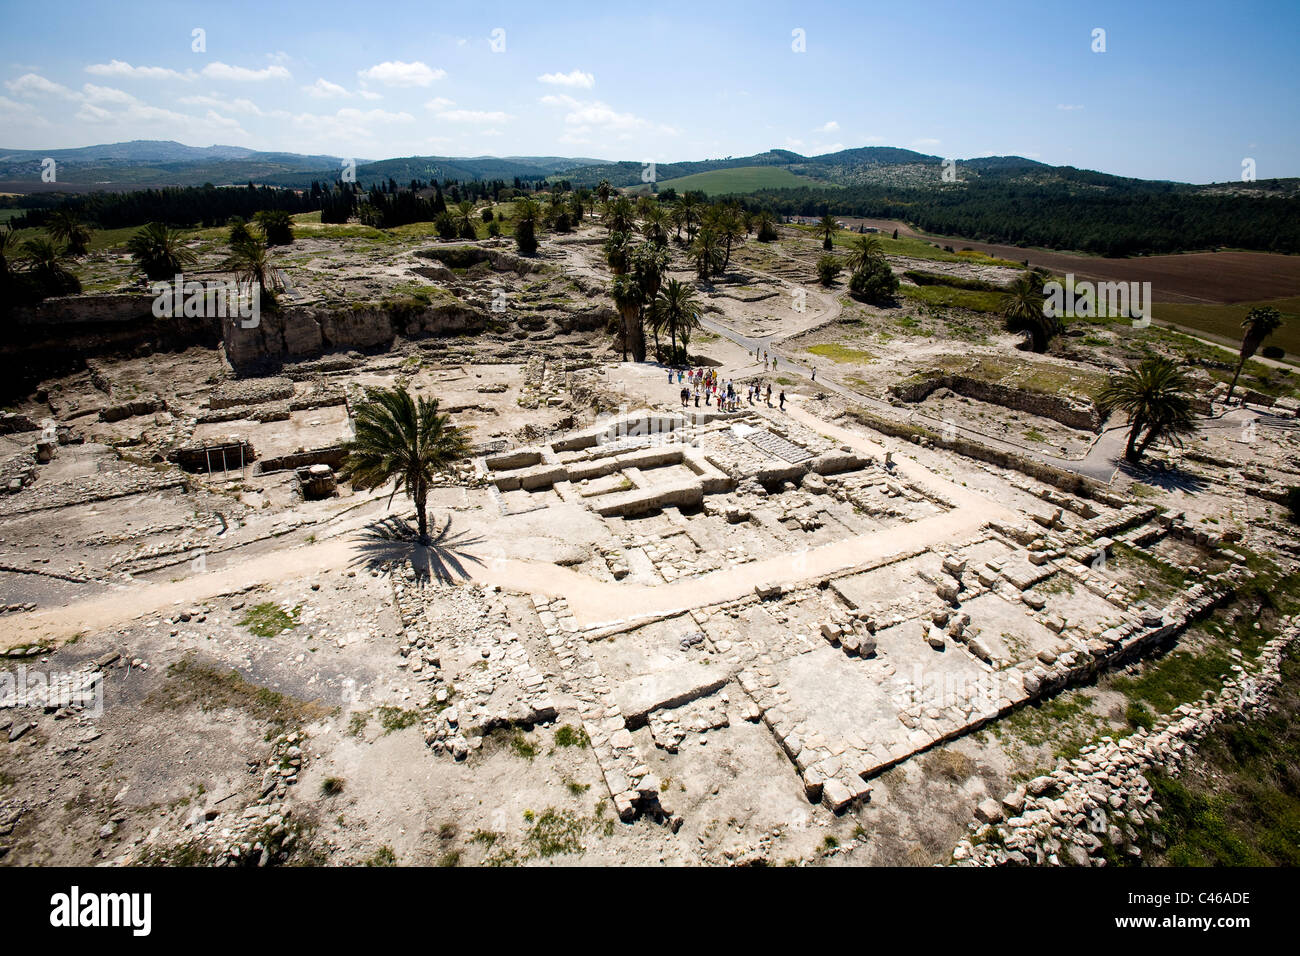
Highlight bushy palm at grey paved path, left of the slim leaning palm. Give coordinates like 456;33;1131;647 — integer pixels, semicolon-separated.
1097;355;1196;463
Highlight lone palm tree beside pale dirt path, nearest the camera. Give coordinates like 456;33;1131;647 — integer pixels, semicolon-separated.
342;386;469;545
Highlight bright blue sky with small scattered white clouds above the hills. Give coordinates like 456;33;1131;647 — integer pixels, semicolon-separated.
0;0;1300;182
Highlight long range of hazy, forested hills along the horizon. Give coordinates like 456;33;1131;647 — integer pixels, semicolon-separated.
0;140;1300;256
